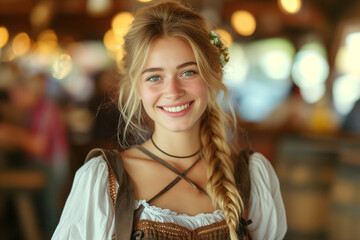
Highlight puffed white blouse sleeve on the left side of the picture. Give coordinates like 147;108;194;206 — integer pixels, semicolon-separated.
51;156;114;240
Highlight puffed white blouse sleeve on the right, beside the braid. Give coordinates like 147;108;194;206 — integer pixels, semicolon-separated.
248;153;287;240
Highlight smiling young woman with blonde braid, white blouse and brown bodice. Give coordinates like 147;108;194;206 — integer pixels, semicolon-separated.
53;2;286;240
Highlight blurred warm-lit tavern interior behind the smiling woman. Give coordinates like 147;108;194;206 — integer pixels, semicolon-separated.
0;0;360;240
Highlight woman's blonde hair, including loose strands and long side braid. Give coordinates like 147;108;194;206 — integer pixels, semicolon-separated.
118;1;244;240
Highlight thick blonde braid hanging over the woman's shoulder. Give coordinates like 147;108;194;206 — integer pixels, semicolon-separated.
200;110;244;240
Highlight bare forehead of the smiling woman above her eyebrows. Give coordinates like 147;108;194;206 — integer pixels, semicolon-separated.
145;36;196;68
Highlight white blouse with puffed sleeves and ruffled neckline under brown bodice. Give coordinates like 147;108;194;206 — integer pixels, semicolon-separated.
52;153;287;240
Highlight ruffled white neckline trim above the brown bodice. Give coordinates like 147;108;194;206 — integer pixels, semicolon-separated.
135;200;225;230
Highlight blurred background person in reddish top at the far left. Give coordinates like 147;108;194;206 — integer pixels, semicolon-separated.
0;69;69;238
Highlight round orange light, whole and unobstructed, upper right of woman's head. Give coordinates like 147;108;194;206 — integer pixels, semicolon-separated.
231;10;256;36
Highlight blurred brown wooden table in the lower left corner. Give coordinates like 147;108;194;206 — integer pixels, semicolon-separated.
0;169;46;240
